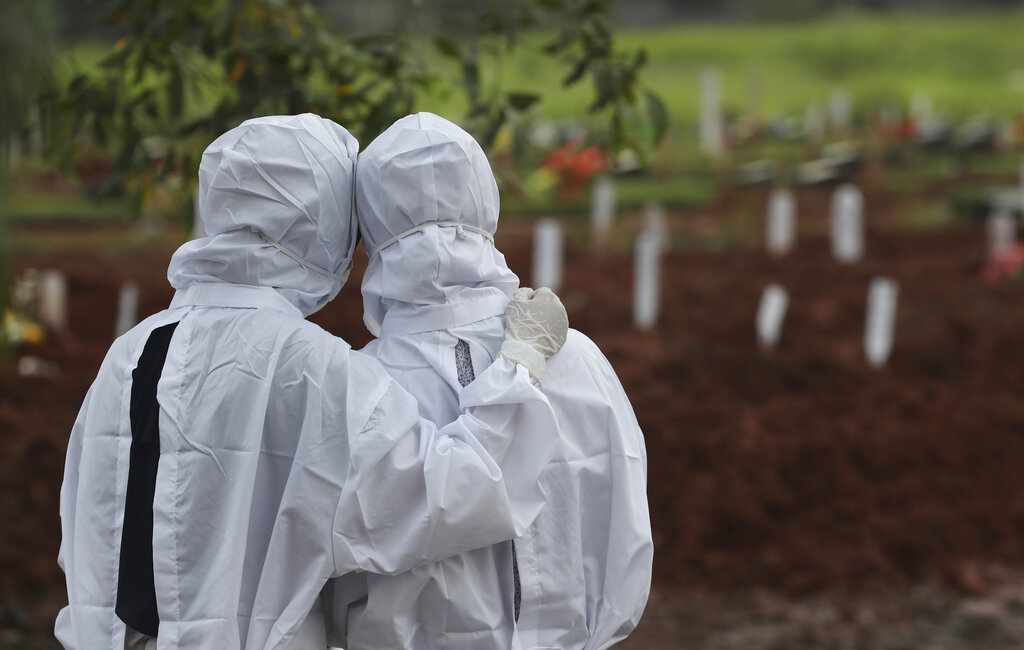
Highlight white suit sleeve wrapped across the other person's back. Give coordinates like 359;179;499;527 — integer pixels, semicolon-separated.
333;353;559;575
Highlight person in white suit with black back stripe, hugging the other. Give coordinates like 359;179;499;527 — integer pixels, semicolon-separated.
55;115;567;650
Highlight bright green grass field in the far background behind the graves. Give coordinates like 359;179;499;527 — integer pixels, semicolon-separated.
411;11;1024;142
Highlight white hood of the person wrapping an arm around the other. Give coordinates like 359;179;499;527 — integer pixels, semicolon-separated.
167;114;358;316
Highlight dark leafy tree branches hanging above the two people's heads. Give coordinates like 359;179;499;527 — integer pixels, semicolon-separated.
44;0;666;224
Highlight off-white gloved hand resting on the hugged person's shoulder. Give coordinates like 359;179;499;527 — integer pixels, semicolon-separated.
499;288;569;384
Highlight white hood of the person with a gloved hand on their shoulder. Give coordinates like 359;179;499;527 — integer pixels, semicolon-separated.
355;113;519;336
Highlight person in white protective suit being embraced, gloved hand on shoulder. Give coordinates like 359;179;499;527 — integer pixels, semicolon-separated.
328;113;653;650
